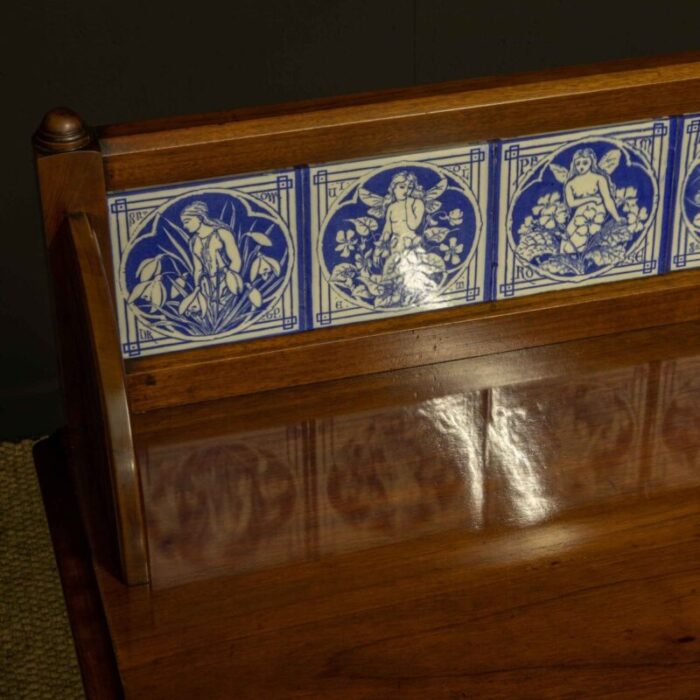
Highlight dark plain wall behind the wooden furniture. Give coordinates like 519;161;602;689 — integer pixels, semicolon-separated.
0;0;700;439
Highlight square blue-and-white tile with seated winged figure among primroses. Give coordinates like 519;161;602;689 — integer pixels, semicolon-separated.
495;119;673;299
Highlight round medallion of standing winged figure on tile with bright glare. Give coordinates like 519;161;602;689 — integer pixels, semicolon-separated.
318;163;481;310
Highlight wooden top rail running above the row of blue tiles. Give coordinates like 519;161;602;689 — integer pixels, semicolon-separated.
98;53;700;190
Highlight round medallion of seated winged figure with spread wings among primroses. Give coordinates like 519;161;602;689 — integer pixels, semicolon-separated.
507;138;659;282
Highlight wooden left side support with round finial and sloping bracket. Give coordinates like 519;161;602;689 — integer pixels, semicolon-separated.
34;117;148;583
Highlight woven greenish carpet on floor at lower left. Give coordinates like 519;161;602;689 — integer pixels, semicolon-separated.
0;440;84;700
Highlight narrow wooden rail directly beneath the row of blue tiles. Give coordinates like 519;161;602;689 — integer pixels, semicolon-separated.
127;270;700;412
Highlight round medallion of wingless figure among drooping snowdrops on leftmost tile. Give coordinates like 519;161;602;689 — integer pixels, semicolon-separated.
120;189;293;340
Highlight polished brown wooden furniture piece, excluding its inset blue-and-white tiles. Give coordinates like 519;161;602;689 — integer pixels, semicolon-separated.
34;55;700;698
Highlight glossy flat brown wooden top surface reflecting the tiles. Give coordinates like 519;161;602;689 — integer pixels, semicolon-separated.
98;323;700;700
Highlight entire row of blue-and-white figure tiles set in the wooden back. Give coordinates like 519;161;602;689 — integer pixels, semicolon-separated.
108;115;700;357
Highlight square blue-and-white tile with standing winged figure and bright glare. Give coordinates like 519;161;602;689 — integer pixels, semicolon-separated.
307;145;490;328
